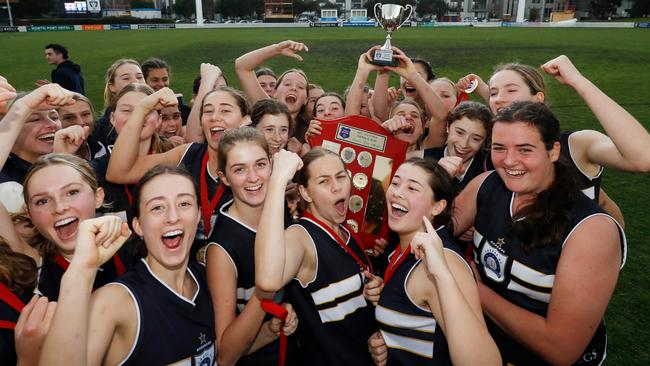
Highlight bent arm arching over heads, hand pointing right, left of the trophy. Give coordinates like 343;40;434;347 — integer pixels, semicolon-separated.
235;41;309;104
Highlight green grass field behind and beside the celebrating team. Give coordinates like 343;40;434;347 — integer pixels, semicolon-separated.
0;28;650;365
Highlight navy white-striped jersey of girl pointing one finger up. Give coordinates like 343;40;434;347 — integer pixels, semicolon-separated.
375;227;471;366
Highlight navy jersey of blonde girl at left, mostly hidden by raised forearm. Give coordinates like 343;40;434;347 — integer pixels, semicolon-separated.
36;253;129;301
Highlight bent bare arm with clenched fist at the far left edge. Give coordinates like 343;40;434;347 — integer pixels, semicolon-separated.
0;83;74;166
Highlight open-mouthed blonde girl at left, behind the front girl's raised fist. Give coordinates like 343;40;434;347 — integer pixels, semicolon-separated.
23;154;129;301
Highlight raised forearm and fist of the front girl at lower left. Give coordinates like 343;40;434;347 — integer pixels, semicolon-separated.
39;216;130;366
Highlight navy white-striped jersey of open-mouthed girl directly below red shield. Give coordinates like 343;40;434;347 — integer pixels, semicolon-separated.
286;217;377;366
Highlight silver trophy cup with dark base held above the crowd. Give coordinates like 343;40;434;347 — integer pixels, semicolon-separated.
372;3;413;66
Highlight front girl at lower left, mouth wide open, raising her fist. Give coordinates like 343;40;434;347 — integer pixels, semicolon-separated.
41;166;216;365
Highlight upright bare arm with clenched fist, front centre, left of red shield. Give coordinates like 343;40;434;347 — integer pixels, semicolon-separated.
255;150;306;292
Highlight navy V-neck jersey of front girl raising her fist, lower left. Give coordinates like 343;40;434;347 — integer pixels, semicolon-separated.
114;259;216;366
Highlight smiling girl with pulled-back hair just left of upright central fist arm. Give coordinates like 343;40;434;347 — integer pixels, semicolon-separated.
206;127;298;365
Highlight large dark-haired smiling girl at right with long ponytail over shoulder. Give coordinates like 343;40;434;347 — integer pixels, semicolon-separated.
454;102;627;365
